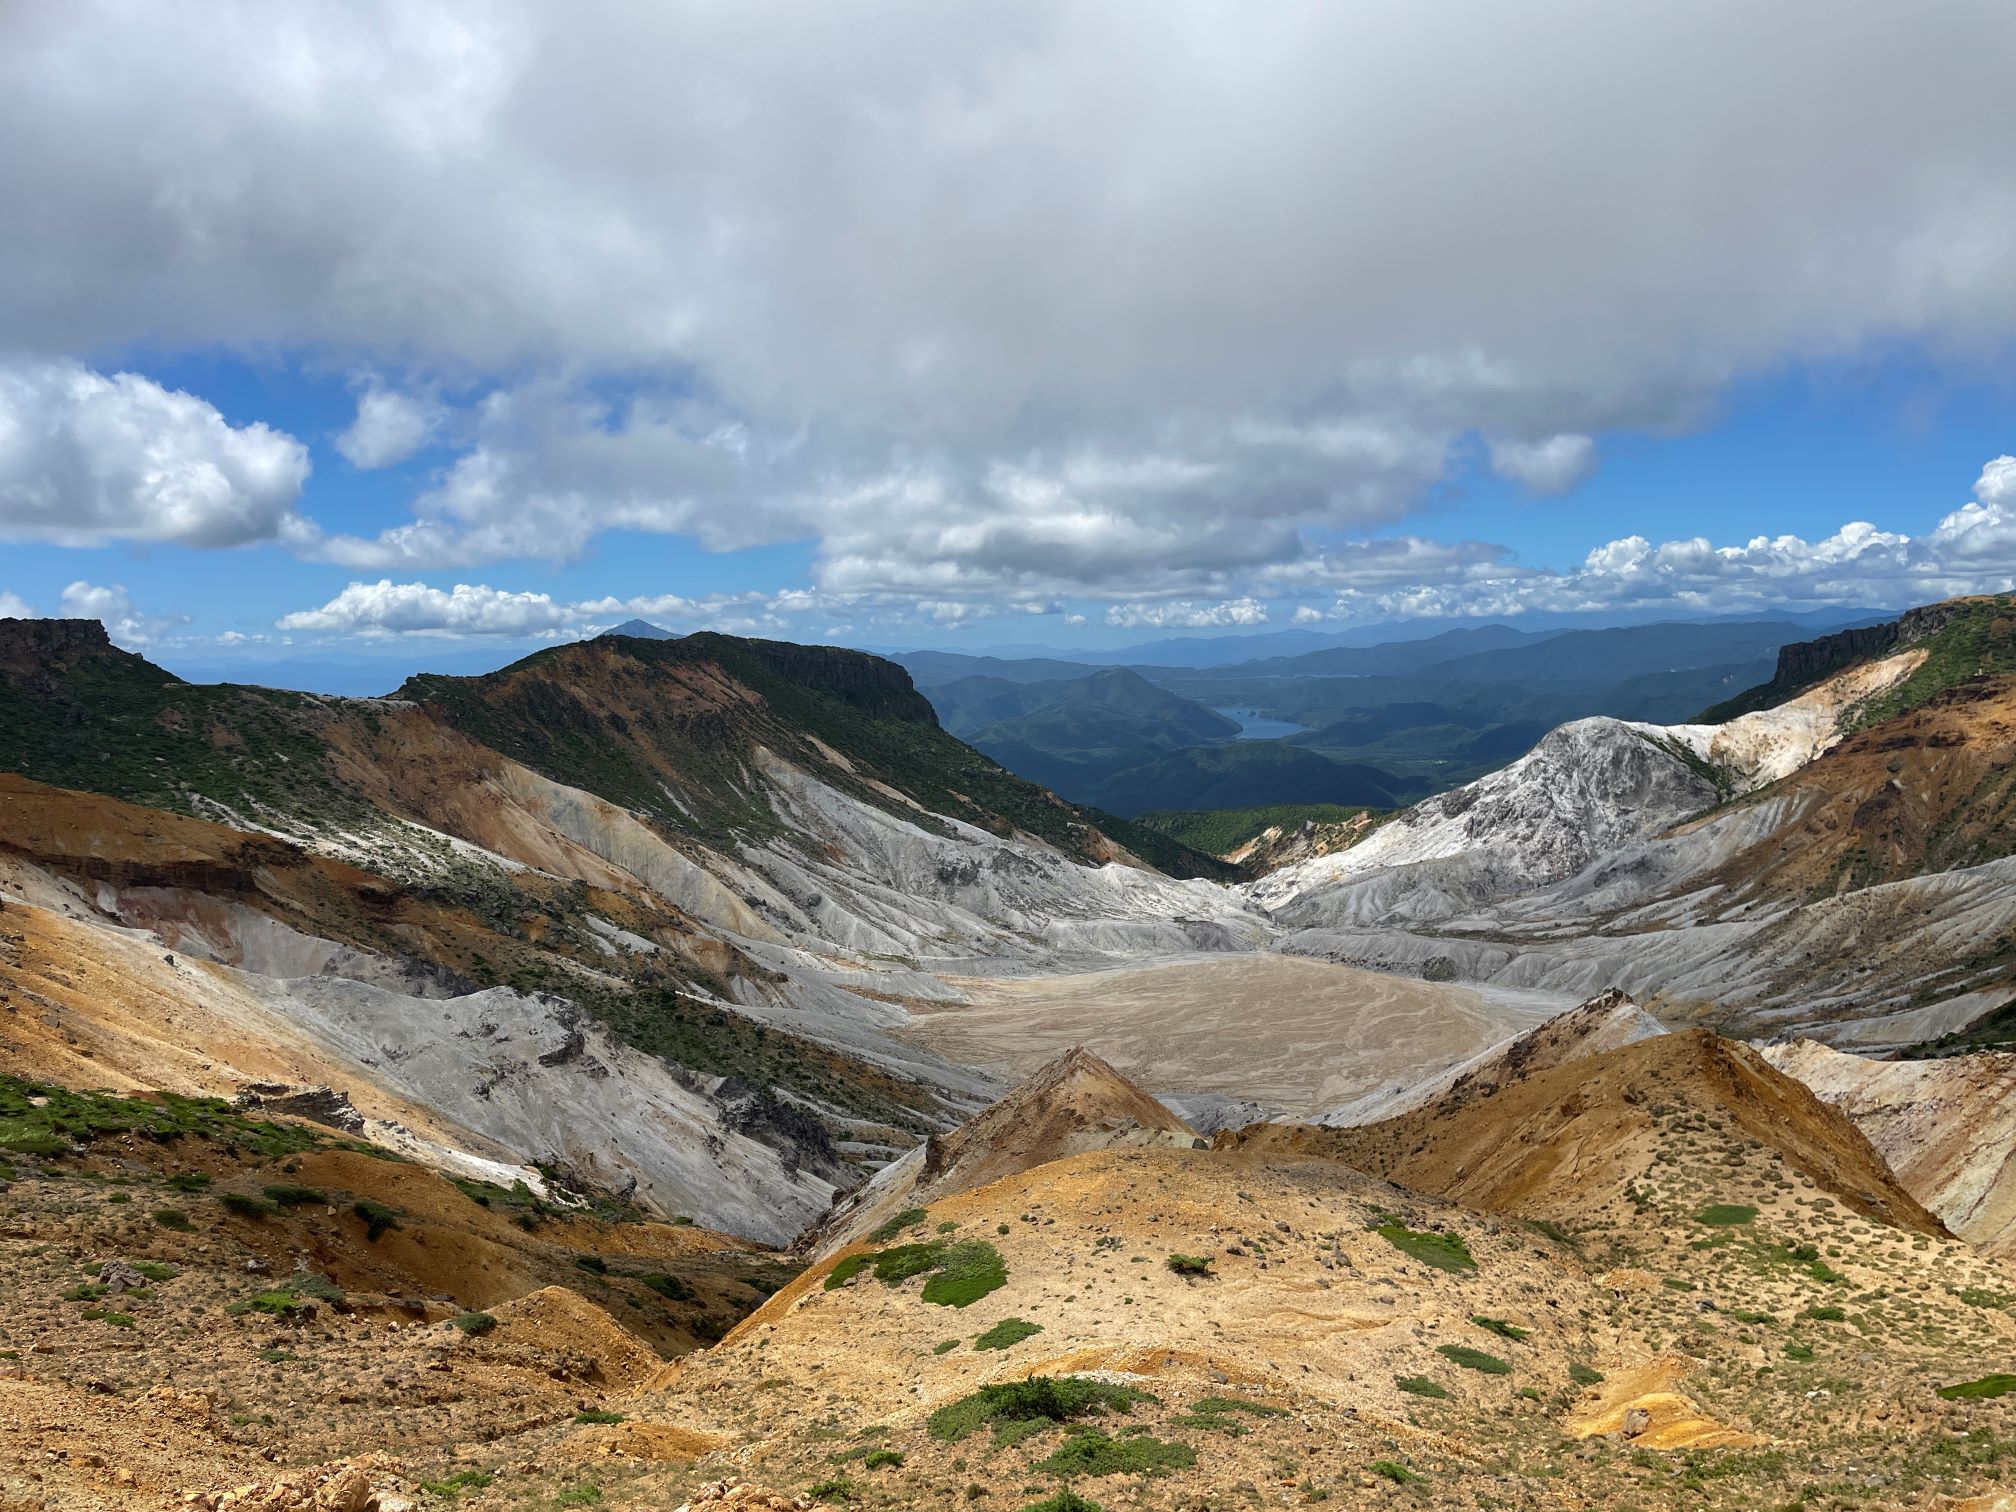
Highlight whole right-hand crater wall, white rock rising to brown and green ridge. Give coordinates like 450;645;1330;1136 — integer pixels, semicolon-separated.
1250;599;2016;1048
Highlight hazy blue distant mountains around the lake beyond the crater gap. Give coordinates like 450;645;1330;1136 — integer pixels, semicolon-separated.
895;613;1886;814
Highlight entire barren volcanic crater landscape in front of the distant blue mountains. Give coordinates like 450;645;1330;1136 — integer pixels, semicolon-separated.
0;597;2016;1512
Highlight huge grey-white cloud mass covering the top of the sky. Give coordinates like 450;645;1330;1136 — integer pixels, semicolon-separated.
0;0;2016;603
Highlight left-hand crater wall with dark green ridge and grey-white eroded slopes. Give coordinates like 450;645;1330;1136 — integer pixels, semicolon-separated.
0;621;1264;1240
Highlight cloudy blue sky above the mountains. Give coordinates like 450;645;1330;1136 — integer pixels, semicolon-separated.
0;0;2016;657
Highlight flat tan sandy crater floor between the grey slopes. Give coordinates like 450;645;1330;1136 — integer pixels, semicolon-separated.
901;954;1564;1117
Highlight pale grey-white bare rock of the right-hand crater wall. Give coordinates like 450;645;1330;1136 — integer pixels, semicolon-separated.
1246;651;2016;1048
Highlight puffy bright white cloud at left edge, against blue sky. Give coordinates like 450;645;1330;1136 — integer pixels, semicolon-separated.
0;361;310;546
